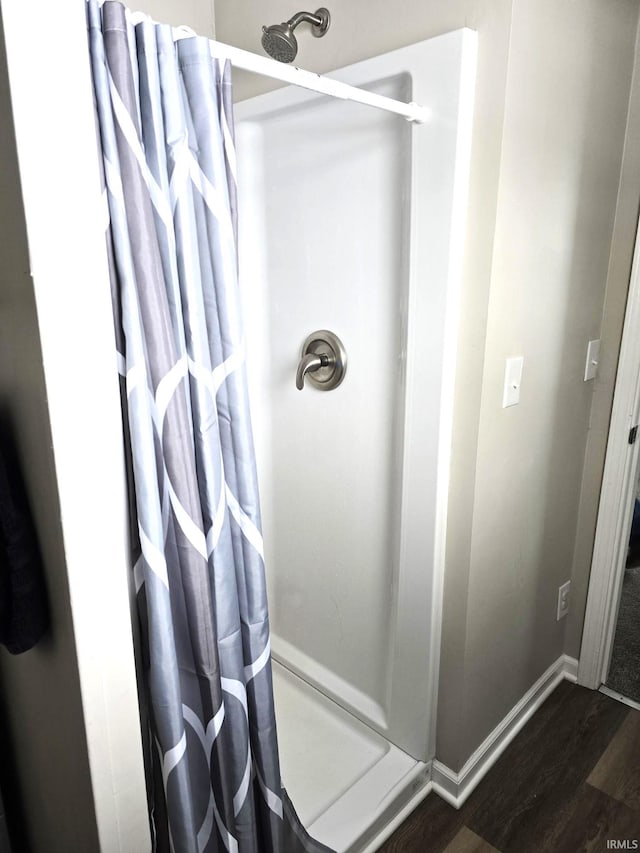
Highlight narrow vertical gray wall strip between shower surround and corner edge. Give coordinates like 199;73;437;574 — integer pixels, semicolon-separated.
436;4;512;770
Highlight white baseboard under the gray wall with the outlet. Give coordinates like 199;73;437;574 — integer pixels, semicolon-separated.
431;655;578;809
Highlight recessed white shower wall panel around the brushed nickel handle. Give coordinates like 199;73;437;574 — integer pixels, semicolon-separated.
239;79;411;718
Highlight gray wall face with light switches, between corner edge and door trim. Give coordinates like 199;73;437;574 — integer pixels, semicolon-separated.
452;0;638;763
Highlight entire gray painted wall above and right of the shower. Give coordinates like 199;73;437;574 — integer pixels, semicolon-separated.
216;0;638;769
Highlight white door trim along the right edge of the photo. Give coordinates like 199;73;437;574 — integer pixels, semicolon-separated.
578;216;640;689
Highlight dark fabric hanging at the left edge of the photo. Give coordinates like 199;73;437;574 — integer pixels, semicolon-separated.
0;434;49;655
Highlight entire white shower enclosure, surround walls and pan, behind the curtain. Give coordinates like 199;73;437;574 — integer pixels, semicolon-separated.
236;30;475;851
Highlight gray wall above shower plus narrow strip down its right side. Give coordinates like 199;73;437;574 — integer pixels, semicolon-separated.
216;0;512;767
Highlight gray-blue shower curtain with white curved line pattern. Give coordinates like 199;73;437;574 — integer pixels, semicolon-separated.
87;0;327;853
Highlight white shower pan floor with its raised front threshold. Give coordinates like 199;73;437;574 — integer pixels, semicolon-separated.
273;660;430;853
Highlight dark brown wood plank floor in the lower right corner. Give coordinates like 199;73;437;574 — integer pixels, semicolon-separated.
380;681;640;853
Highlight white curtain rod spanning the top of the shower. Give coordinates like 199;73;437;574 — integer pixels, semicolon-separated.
173;27;430;124
